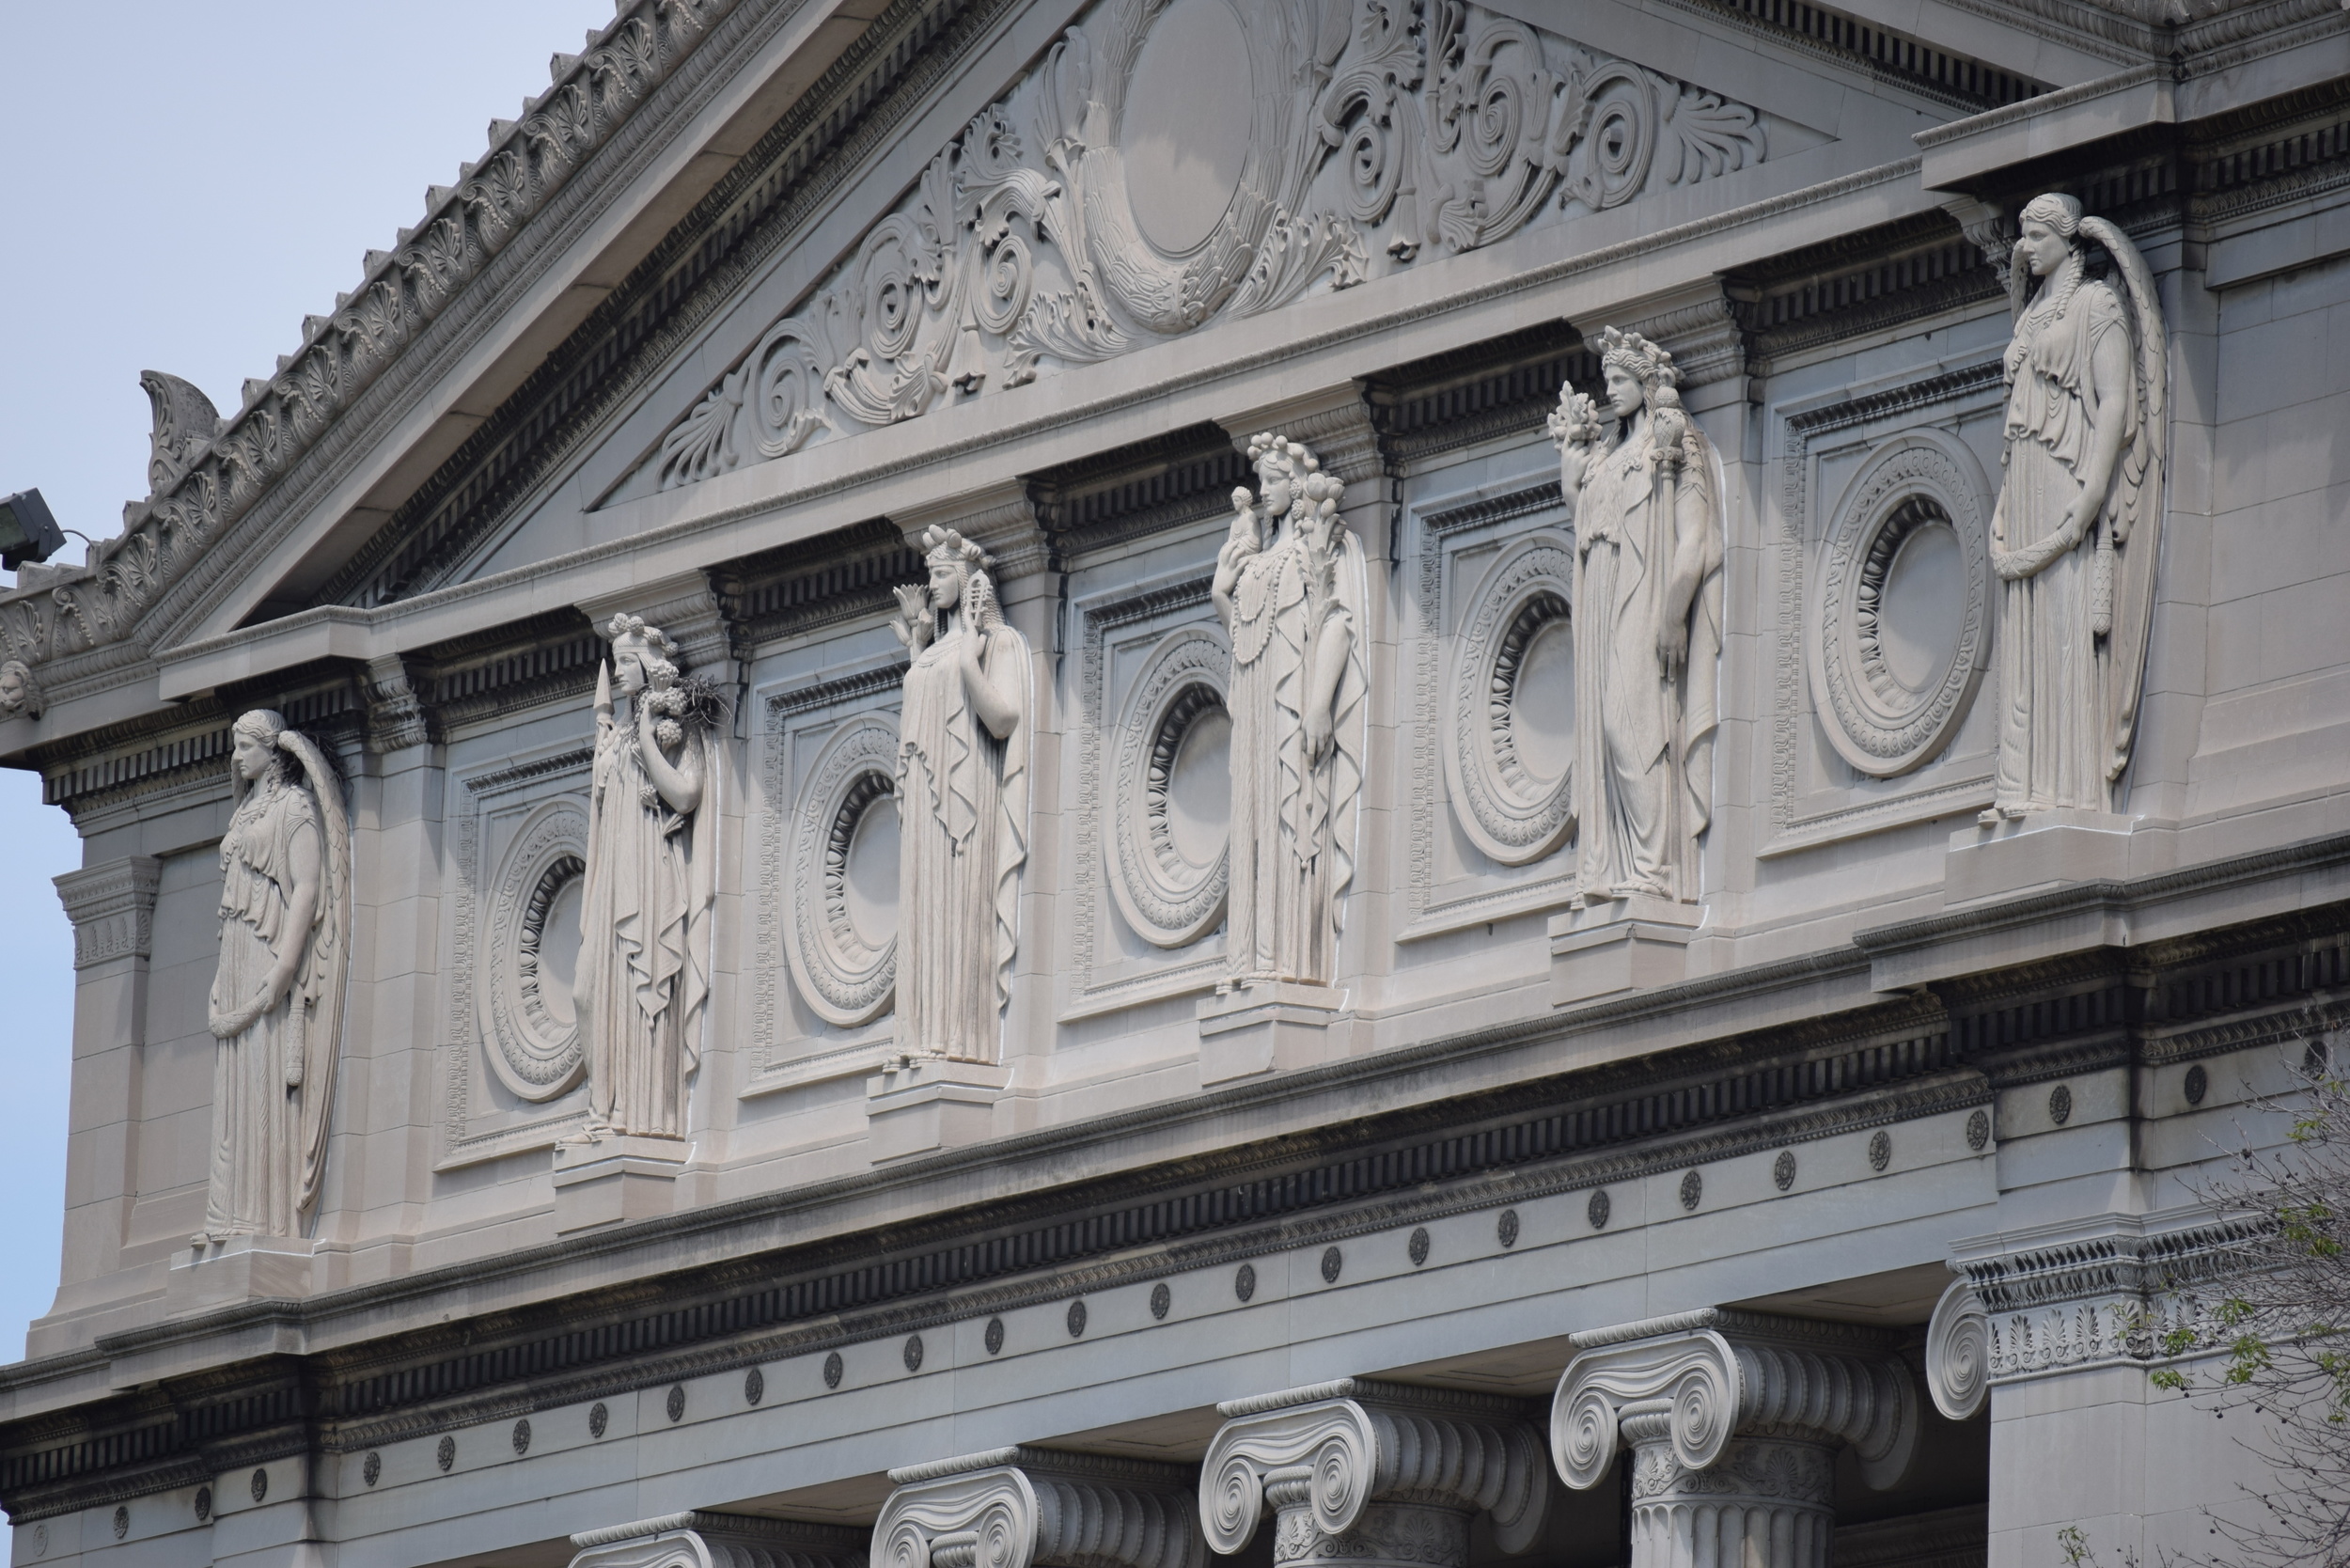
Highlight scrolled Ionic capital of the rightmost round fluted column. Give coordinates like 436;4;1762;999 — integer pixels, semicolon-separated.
1551;1309;1918;1490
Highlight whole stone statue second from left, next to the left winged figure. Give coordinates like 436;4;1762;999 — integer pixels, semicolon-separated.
573;616;722;1137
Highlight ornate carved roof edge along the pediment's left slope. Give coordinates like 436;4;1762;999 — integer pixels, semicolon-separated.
0;0;738;663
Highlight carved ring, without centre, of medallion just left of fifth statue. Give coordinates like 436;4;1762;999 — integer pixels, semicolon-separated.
1446;534;1574;865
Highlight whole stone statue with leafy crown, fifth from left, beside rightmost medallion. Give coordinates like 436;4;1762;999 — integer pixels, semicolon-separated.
1551;327;1725;907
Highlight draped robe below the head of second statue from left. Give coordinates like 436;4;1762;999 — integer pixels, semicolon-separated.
576;696;717;1137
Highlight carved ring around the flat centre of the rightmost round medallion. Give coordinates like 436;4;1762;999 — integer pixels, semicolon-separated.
1805;431;1991;778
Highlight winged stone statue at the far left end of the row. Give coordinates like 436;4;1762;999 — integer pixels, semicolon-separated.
193;708;351;1246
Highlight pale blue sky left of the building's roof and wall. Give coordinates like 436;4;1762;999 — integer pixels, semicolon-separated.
0;0;614;1358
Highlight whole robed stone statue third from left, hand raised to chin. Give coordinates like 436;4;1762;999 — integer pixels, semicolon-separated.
891;529;1034;1062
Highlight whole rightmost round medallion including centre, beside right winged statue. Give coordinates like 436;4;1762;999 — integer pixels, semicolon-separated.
1805;432;1991;778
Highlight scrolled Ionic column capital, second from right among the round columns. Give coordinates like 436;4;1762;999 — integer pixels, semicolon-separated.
1198;1377;1551;1568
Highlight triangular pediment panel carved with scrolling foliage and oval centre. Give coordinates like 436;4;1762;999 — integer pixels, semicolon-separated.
630;0;1777;492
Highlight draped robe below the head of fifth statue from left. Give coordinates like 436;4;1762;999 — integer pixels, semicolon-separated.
1574;426;1723;901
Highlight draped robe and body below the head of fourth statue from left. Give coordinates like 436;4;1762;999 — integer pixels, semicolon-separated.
1225;494;1371;985
